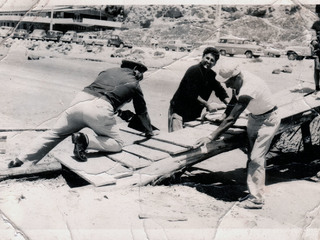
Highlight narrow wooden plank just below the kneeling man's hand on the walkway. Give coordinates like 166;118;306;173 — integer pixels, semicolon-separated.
137;138;189;155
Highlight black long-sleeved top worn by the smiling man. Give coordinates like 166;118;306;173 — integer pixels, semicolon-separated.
170;63;228;122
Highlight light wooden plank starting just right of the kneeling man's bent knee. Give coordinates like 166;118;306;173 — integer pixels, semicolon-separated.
123;145;170;161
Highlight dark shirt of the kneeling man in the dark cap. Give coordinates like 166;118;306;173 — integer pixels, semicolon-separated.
84;68;147;114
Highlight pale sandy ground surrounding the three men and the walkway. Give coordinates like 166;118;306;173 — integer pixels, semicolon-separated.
0;41;320;240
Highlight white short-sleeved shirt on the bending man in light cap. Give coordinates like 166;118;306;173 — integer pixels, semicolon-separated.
236;71;275;115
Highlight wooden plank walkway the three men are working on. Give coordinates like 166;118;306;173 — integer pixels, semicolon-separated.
0;82;320;187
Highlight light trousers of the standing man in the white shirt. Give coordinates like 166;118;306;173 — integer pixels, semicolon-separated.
247;111;280;200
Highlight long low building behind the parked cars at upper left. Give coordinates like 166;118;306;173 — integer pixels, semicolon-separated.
0;6;123;32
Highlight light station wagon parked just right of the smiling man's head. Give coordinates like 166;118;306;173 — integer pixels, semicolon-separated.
215;36;263;58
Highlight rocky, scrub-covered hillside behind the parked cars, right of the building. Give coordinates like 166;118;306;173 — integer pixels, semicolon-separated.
114;5;317;47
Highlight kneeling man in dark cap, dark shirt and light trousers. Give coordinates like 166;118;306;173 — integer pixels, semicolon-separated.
8;60;153;168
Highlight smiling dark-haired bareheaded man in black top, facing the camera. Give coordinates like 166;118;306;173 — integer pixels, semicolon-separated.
168;47;228;132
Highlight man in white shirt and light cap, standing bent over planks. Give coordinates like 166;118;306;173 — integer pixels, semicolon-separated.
194;65;280;209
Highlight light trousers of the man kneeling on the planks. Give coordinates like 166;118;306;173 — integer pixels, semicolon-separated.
18;92;123;162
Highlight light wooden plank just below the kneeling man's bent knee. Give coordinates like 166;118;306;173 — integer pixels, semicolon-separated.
108;151;151;170
